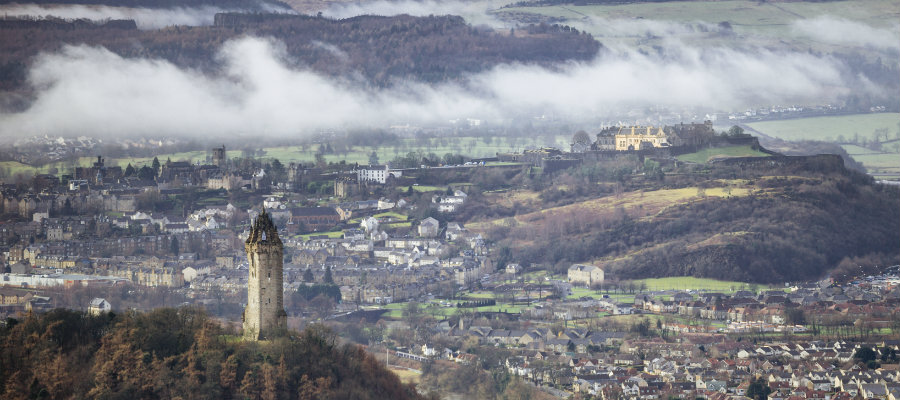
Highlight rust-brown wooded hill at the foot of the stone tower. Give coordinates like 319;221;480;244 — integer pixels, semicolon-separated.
0;307;419;399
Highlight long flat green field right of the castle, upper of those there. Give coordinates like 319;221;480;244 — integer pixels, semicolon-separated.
747;113;900;142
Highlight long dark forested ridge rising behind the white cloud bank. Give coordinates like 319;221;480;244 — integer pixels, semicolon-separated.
0;14;601;95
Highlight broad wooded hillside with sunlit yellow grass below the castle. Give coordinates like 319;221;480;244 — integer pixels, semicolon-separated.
455;156;900;283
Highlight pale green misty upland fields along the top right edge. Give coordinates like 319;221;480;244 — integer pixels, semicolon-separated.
495;0;900;51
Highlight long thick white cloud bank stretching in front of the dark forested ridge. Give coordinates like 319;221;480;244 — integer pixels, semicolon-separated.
0;37;879;137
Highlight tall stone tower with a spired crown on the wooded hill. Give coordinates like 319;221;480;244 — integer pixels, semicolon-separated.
243;208;287;340
